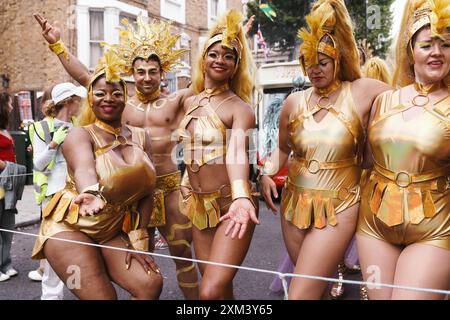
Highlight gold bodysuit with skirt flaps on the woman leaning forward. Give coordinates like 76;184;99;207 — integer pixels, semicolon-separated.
32;124;155;259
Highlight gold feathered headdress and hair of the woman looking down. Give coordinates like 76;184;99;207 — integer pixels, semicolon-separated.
298;0;361;81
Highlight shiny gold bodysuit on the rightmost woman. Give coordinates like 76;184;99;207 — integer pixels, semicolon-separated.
358;91;450;249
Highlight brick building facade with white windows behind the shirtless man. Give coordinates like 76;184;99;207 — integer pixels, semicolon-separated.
0;0;242;125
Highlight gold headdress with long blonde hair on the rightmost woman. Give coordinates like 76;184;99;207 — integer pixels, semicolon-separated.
393;0;450;86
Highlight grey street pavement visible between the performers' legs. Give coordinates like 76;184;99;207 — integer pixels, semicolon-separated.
0;186;360;300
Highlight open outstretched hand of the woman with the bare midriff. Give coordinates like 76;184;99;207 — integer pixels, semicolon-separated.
220;198;259;239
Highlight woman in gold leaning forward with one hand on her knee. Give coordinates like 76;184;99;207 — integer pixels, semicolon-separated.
32;51;162;299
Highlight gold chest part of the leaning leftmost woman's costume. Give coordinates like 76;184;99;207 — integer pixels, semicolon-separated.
83;122;156;204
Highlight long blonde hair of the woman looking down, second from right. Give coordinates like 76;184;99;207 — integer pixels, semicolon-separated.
302;0;361;81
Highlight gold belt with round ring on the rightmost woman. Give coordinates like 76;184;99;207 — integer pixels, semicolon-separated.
374;163;450;192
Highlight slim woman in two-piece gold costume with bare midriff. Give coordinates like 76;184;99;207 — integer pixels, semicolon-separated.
179;10;259;299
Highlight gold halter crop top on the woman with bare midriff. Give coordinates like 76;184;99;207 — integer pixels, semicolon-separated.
178;94;236;172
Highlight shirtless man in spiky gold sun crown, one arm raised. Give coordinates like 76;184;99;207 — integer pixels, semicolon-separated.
34;14;198;300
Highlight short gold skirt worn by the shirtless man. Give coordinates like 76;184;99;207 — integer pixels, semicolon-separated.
148;171;181;227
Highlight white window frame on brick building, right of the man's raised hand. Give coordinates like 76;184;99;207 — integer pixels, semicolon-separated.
75;0;148;66
